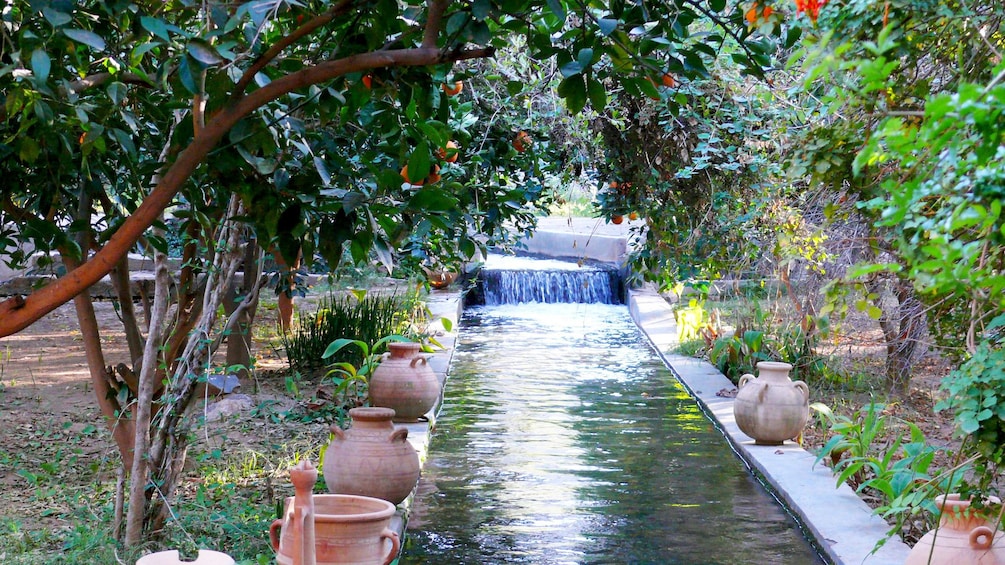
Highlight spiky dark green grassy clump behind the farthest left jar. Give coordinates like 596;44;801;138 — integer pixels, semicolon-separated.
282;293;417;374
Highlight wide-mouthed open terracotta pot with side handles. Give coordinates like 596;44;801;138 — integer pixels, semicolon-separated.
268;495;401;565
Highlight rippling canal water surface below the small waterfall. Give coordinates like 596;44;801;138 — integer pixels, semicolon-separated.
401;304;820;565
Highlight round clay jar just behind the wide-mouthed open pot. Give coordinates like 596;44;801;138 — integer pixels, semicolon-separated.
322;407;419;504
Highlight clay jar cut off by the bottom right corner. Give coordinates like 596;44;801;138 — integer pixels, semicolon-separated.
903;494;1005;565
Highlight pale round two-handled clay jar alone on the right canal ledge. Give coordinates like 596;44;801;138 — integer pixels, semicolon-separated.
733;361;810;445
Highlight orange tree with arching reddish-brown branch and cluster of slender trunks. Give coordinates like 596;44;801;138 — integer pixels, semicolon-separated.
0;0;783;545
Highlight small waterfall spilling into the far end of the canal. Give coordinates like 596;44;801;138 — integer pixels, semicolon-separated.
470;257;621;305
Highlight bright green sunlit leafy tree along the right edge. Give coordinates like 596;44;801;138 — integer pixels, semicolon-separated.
787;0;1005;393
